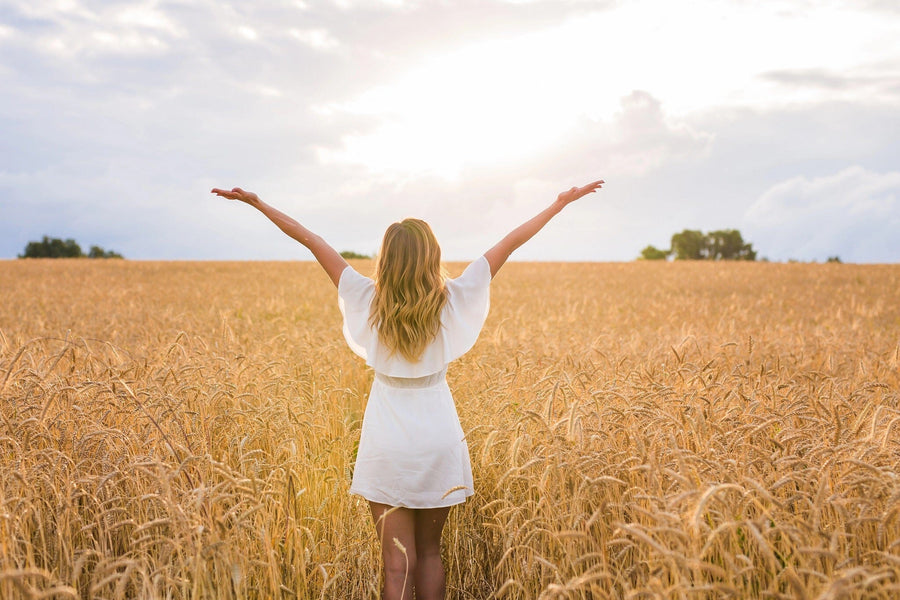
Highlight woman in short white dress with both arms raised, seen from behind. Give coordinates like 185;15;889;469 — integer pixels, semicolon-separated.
212;180;603;600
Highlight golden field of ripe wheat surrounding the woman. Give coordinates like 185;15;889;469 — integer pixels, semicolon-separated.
0;260;900;600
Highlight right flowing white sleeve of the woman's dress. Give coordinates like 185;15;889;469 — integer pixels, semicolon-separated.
442;256;491;362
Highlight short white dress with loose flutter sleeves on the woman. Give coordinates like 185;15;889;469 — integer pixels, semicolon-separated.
338;256;491;508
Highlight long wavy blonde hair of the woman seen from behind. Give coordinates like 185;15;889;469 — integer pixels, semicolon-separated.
369;219;447;362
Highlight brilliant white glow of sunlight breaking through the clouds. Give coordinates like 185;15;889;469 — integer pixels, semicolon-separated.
319;0;900;179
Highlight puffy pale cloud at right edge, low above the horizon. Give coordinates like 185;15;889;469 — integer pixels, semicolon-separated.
746;166;900;262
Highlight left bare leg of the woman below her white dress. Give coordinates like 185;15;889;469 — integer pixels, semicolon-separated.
369;502;416;600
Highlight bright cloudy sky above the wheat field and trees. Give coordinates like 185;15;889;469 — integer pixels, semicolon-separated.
0;0;900;263
